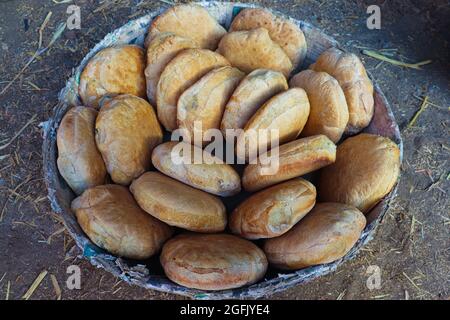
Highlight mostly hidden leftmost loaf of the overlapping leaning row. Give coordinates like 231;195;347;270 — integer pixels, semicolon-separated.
145;32;197;105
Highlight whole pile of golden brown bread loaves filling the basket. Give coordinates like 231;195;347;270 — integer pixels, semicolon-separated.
57;4;400;290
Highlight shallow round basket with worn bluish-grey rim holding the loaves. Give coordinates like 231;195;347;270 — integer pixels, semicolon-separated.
43;2;403;299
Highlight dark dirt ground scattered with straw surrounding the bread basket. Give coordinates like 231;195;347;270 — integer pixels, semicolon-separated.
0;0;450;299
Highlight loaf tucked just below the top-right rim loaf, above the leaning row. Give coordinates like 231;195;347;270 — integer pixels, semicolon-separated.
217;28;292;77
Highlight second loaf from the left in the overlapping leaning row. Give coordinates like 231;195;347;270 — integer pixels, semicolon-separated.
156;49;230;131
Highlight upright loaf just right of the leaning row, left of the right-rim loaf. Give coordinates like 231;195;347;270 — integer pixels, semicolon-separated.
289;70;348;143
